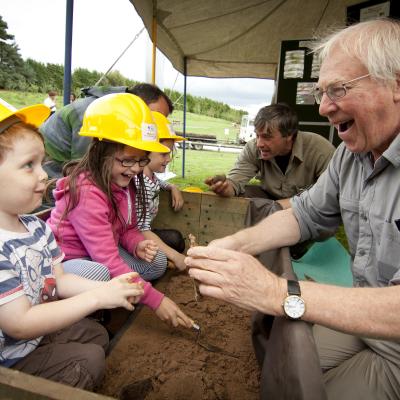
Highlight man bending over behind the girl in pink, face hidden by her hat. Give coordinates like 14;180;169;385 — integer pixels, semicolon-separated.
39;83;174;178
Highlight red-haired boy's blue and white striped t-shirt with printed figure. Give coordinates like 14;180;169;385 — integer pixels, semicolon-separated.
0;215;63;367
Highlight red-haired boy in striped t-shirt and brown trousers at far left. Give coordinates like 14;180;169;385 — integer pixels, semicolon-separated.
0;101;143;390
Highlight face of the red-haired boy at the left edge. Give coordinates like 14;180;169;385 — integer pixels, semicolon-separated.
0;133;47;218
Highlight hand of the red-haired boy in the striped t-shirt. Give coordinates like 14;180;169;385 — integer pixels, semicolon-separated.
93;272;144;311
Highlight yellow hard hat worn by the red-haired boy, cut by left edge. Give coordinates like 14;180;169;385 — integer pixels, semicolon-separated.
0;99;50;132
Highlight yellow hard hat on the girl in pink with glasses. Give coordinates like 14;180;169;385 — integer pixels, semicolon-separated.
79;93;170;153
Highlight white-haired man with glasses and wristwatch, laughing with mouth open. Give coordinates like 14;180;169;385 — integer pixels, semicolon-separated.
186;20;400;400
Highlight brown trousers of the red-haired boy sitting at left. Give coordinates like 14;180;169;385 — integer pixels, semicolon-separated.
12;319;108;390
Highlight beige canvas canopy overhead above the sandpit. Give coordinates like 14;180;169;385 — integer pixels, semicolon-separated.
130;0;360;79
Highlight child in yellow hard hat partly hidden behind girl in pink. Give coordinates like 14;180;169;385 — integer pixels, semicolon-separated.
136;111;186;271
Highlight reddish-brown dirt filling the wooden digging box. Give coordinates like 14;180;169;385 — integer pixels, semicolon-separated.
99;273;260;400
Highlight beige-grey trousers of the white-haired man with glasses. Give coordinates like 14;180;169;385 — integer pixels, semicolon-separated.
313;325;400;400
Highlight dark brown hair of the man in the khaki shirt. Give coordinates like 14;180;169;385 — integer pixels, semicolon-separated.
254;103;299;137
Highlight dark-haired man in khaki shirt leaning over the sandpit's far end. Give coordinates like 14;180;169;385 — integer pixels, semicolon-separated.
205;103;335;208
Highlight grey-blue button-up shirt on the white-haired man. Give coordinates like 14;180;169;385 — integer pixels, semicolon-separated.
291;135;400;287
